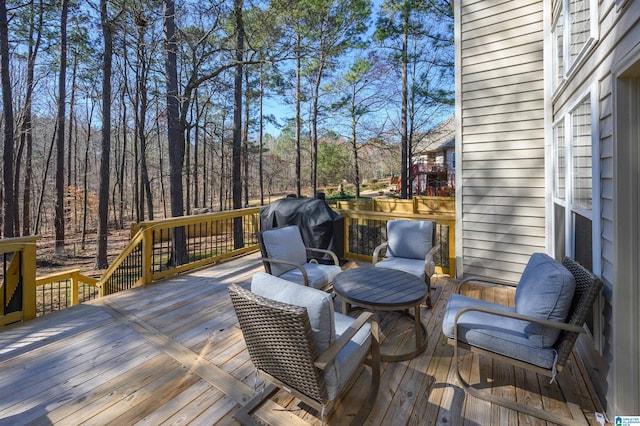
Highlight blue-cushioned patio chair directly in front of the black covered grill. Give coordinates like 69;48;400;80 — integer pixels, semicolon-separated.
258;225;342;289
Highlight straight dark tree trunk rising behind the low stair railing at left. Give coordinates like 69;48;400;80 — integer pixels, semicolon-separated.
54;0;69;255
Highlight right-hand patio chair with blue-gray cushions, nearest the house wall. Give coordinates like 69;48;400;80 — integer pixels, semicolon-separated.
442;253;602;424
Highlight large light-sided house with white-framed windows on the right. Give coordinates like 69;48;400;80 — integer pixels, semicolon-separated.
453;0;640;419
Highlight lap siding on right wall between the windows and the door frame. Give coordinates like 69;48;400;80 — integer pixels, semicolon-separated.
552;1;640;414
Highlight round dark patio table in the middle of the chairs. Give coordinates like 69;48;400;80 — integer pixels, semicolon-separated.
333;267;428;362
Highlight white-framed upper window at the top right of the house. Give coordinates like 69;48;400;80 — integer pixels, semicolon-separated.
551;0;598;90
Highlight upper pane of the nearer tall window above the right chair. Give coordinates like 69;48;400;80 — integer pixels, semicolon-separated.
571;98;592;210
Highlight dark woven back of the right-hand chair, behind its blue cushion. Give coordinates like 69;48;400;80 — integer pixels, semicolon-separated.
554;257;602;370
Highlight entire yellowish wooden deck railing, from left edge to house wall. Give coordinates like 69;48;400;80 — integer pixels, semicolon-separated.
0;200;455;327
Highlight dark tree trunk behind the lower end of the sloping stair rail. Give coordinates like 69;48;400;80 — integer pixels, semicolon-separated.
96;0;113;269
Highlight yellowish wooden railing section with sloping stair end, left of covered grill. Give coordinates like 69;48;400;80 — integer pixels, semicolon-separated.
100;207;260;294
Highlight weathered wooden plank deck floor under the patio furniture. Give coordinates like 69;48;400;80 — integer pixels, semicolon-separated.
0;254;597;425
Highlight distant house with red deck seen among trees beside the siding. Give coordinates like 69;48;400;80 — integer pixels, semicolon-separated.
411;116;456;194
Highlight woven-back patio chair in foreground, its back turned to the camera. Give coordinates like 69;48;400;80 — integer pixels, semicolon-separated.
229;272;380;425
